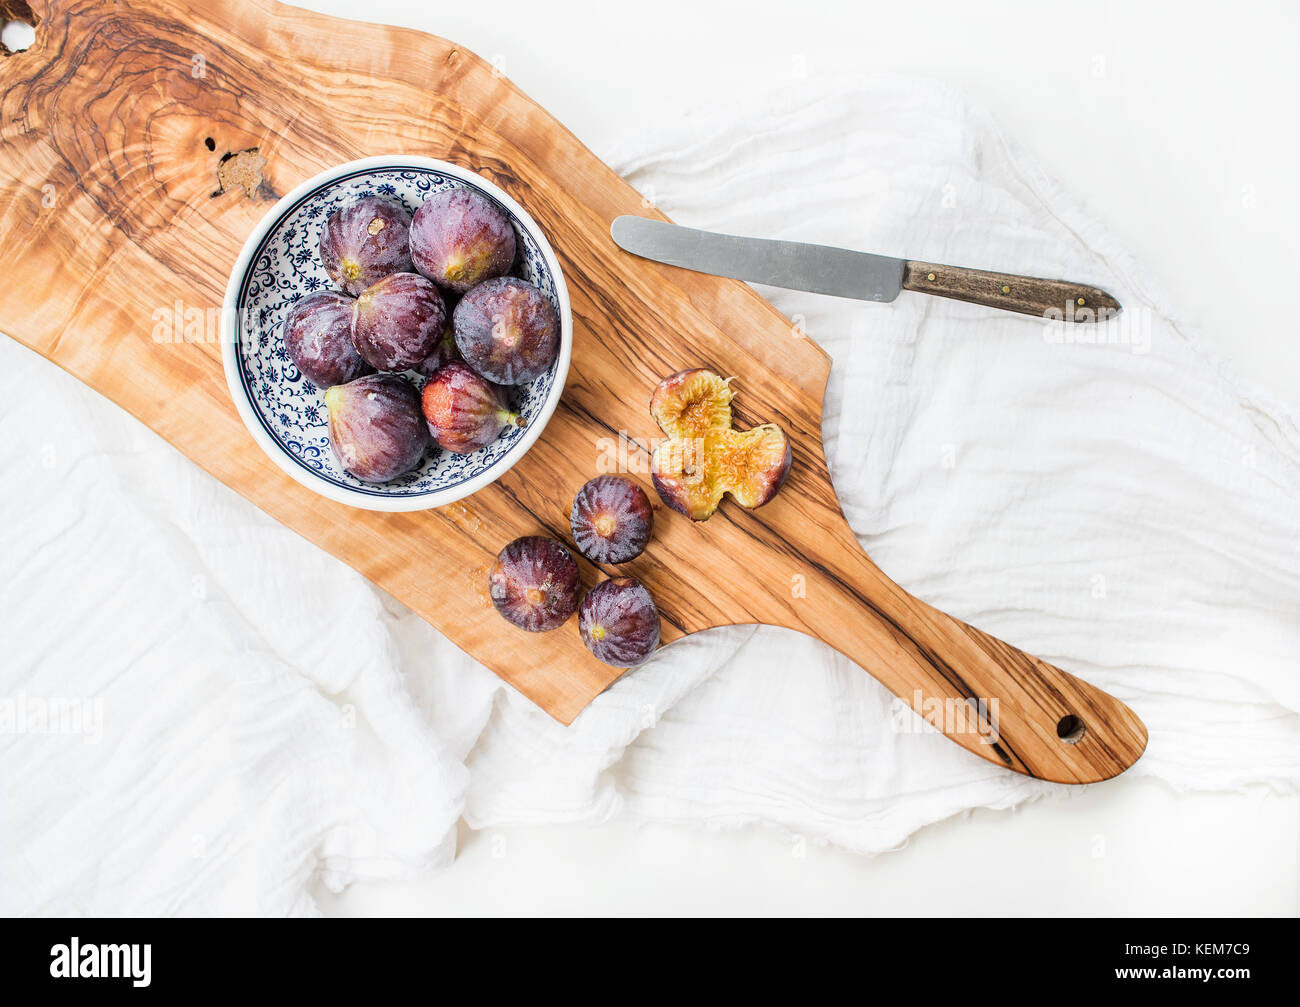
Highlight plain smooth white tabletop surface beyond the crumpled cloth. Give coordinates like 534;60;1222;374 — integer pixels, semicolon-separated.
287;0;1300;915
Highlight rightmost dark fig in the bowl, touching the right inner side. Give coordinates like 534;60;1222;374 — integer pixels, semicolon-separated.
452;277;560;385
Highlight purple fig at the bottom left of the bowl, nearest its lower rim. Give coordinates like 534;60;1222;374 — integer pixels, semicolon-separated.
325;374;429;482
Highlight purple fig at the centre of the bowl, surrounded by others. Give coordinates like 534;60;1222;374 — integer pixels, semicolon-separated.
352;273;447;370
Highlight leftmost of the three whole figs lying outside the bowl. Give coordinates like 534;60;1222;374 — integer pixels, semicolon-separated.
488;535;581;633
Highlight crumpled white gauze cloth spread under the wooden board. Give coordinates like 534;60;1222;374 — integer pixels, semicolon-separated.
0;79;1300;913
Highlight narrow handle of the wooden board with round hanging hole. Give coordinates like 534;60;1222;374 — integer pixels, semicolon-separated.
802;531;1147;784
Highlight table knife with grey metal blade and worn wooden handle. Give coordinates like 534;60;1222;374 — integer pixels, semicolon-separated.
610;216;1121;322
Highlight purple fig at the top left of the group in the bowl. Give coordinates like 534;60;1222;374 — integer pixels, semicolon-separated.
320;196;411;298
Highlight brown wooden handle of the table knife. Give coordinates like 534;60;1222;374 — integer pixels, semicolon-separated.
902;262;1121;322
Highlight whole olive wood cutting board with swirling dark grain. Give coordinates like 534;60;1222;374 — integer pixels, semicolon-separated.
0;0;1145;782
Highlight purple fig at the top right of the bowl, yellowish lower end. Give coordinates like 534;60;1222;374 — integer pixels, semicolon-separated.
411;188;515;294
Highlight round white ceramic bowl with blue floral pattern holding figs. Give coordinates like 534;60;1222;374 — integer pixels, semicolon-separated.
221;155;573;511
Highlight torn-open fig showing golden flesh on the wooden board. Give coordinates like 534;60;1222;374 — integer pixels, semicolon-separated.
650;368;790;521
